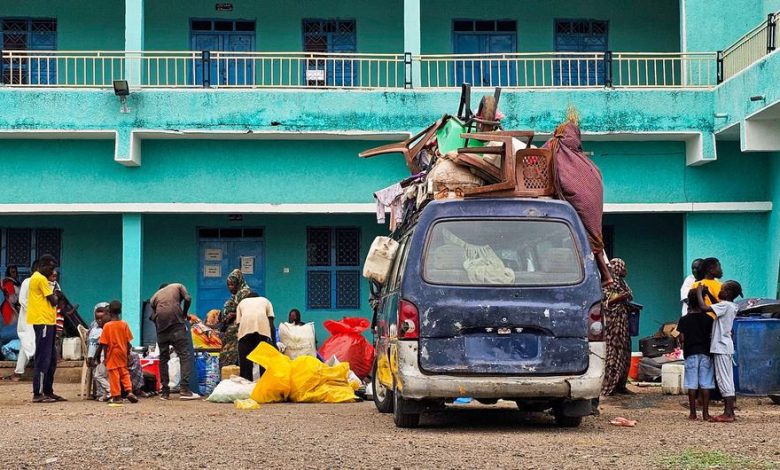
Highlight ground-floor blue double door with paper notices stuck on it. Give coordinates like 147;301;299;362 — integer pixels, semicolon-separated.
197;229;265;316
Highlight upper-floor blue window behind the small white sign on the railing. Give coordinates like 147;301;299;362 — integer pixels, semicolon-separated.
303;18;359;87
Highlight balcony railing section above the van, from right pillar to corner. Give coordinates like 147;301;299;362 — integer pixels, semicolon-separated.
415;52;717;88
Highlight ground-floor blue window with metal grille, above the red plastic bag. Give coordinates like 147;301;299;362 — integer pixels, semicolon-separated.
306;227;360;310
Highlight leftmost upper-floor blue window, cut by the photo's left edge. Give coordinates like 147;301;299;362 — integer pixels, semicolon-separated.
0;18;57;85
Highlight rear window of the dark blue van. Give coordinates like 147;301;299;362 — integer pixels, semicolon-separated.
423;219;583;286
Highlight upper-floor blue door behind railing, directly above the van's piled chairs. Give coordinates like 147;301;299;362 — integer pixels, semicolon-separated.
450;19;517;87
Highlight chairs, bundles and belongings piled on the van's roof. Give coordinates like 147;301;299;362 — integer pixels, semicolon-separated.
360;85;612;283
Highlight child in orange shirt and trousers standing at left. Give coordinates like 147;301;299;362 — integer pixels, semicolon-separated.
95;300;138;403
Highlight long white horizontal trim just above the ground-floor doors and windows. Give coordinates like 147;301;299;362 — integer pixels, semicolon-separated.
0;201;772;215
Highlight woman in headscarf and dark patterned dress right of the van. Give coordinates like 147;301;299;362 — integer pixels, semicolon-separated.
601;258;633;395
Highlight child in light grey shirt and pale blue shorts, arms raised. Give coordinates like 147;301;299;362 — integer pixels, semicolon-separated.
696;281;742;423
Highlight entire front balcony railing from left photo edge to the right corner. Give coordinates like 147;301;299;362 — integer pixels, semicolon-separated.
0;51;717;89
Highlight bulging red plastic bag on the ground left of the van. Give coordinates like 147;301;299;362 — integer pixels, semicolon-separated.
319;317;374;379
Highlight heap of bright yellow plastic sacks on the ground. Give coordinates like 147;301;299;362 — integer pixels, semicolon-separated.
247;343;355;403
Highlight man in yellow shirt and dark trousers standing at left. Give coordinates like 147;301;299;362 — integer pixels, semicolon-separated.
27;255;65;403
